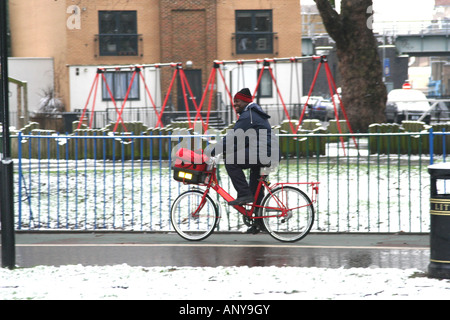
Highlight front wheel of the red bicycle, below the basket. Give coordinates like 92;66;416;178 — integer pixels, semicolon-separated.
170;190;219;241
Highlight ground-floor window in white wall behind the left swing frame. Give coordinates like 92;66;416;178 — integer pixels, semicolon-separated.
102;71;139;101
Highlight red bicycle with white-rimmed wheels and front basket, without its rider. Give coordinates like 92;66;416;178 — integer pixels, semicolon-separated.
170;158;319;242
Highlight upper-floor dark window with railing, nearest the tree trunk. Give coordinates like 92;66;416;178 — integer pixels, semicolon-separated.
235;10;273;54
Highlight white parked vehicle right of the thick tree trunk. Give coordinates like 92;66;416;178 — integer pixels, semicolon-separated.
386;89;431;123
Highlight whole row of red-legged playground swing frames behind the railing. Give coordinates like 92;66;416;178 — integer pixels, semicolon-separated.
77;56;357;150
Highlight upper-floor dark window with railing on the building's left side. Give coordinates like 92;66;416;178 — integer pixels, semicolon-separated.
98;11;139;56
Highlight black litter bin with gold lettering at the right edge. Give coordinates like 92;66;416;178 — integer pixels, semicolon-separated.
428;163;450;279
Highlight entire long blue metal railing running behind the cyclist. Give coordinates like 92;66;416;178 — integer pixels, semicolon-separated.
15;130;449;232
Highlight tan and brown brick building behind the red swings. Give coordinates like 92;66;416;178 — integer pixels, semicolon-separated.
9;0;301;127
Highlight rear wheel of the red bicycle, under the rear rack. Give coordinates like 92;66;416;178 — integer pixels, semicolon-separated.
258;186;314;242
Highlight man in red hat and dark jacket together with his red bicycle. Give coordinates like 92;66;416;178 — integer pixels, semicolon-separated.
170;89;319;242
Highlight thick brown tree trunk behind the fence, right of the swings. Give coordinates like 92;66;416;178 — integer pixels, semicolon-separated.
314;0;387;132
